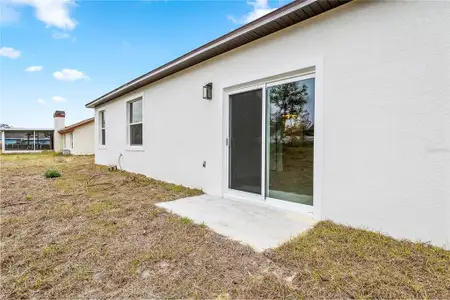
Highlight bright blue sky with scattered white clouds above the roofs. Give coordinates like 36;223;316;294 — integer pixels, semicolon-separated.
0;0;285;127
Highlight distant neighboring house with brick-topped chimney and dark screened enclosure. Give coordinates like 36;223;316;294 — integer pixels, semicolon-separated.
0;111;94;155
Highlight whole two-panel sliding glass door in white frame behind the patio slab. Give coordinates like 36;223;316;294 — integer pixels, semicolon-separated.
228;75;315;206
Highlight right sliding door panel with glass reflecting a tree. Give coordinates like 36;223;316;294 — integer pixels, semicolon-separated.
266;78;315;205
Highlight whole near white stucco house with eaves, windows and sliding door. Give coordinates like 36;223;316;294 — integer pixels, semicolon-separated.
86;0;450;247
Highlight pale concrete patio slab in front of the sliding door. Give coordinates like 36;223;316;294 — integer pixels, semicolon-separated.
156;195;316;251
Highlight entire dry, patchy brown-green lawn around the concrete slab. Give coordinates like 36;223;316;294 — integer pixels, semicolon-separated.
0;153;450;299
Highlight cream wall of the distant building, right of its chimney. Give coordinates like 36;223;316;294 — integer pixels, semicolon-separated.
64;122;95;155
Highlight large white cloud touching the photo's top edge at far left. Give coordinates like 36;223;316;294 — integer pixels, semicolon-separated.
12;0;77;30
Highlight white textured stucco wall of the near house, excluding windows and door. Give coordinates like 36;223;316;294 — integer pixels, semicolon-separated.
94;1;450;247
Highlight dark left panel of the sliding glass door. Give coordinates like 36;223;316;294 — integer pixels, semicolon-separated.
228;89;263;194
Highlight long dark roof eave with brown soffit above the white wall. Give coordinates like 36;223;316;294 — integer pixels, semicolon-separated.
86;0;352;108
